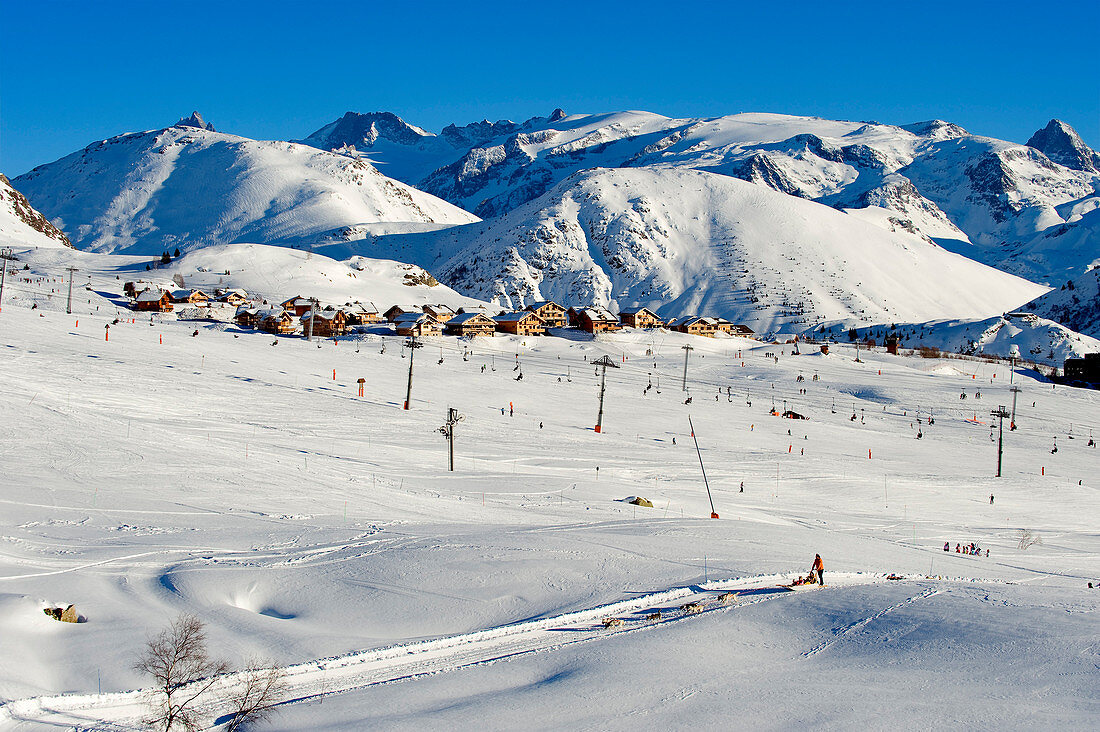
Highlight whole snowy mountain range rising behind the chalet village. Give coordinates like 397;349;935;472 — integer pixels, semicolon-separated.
14;109;1100;329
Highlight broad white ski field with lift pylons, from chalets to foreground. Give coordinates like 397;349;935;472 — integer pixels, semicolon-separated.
0;246;1100;730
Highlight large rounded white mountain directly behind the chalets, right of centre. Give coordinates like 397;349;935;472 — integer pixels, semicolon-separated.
352;167;1046;330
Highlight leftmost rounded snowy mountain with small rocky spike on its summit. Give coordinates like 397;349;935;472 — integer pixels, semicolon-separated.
15;113;476;254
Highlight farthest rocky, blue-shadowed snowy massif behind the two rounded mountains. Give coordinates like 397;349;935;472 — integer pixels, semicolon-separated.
308;110;1100;283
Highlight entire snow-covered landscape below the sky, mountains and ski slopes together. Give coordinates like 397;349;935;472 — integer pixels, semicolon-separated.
0;105;1100;732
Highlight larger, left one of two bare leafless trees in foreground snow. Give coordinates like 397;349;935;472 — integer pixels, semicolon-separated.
134;614;229;732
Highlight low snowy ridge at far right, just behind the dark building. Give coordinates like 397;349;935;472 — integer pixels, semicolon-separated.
806;313;1100;368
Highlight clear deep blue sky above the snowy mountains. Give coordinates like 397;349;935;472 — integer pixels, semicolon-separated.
0;0;1100;177
